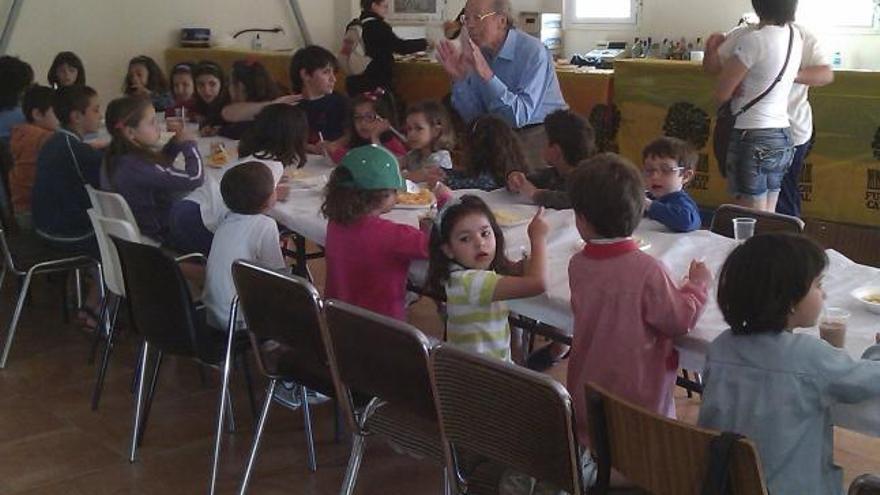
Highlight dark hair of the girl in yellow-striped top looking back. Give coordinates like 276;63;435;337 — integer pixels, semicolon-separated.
425;194;516;296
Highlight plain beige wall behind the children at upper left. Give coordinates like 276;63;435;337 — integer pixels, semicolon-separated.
0;0;340;103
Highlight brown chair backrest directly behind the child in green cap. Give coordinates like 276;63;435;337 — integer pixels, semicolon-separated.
324;300;437;421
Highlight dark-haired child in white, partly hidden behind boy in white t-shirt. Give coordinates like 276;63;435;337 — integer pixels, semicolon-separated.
169;104;309;254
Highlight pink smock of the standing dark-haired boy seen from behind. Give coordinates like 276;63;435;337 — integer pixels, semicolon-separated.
568;239;707;446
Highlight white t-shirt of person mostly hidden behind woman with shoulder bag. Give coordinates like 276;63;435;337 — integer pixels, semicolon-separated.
718;24;831;146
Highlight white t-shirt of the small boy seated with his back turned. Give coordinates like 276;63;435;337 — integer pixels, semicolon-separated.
202;212;285;331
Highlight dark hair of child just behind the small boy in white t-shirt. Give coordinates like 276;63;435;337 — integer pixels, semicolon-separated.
238;103;309;168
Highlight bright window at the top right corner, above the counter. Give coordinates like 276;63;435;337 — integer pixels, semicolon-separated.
797;0;878;30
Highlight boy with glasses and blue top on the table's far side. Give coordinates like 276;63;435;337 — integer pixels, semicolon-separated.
642;137;701;232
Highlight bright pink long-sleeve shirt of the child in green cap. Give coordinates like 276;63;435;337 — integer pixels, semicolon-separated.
324;215;428;320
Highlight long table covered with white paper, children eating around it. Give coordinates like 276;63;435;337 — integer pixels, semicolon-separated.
199;148;880;436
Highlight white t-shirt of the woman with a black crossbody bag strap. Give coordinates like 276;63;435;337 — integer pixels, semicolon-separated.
728;26;803;129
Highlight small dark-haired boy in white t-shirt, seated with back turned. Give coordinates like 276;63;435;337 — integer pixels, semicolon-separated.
204;161;286;330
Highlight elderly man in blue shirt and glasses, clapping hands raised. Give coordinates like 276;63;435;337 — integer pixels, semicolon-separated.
437;0;568;168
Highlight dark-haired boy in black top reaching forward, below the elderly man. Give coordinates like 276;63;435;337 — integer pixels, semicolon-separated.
507;110;596;210
